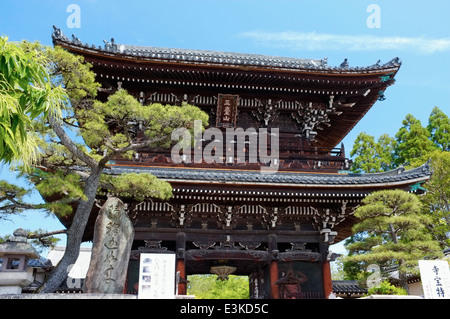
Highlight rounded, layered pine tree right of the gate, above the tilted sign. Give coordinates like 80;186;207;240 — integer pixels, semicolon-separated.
346;190;442;289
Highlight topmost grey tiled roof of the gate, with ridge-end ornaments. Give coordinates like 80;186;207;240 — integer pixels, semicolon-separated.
52;26;401;73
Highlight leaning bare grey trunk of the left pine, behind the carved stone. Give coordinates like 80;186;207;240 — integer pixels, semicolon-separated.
39;167;102;293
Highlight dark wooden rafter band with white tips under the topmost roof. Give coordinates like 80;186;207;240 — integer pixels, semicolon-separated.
92;59;392;96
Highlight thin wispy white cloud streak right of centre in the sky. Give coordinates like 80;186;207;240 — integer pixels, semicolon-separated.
240;31;450;54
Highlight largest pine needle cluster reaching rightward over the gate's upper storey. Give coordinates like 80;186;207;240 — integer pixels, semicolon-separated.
76;89;208;157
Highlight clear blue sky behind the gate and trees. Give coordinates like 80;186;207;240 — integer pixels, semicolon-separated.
0;0;450;255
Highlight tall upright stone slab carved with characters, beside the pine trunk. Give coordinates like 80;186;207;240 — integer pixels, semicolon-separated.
83;197;134;294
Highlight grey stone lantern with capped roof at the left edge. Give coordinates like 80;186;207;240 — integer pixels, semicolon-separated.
0;228;39;294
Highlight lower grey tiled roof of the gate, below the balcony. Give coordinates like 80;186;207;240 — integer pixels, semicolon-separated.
106;163;431;187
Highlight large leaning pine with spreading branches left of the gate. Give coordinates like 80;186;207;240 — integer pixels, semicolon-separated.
0;43;208;292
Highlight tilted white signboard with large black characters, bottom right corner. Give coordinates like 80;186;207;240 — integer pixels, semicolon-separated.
419;260;450;299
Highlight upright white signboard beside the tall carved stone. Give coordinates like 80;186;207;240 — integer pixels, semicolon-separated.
138;253;175;299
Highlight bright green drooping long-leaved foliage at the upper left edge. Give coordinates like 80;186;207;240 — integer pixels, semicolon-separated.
0;37;66;164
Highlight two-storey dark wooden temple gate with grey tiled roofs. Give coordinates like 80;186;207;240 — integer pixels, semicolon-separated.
53;28;430;298
